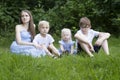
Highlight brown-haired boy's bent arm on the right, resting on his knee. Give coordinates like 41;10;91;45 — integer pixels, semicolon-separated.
95;32;110;45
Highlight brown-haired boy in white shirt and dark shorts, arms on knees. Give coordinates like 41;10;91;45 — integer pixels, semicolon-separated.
74;17;110;57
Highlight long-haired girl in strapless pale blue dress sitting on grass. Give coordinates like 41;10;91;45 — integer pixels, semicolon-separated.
10;10;45;57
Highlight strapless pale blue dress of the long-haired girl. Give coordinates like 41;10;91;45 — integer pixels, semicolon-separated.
10;30;46;57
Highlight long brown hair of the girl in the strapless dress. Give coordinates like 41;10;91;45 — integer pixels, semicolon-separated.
20;10;36;39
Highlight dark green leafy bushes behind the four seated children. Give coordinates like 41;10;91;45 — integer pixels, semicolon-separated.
0;0;120;37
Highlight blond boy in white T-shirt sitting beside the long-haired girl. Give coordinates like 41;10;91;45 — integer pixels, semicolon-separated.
33;21;60;57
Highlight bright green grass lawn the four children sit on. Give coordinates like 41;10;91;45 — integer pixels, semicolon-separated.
0;38;120;80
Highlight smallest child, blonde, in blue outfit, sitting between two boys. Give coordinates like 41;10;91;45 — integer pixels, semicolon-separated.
59;28;76;54
